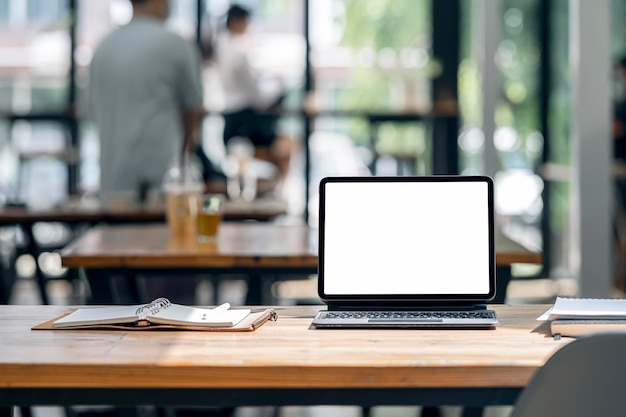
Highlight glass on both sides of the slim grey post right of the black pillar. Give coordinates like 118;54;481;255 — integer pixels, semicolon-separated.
459;0;544;275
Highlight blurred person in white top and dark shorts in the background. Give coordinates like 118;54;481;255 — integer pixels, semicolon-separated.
215;4;291;182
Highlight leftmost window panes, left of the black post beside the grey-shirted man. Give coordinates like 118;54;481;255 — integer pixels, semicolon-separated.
0;0;71;204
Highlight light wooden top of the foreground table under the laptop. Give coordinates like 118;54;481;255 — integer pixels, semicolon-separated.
0;305;570;388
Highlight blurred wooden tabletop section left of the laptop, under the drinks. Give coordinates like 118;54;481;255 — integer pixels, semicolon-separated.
61;223;317;268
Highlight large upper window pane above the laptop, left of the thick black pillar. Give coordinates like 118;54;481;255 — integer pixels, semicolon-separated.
310;0;432;111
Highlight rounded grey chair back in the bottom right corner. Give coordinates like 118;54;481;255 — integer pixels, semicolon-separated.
511;332;626;417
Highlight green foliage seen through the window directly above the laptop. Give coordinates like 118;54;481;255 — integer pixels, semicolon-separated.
324;0;433;164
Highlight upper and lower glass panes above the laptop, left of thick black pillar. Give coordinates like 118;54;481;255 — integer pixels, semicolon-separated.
309;0;428;191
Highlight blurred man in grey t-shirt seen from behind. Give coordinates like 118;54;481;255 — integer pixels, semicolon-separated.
88;0;204;201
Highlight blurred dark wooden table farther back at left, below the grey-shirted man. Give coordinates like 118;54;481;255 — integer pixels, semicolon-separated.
0;198;287;304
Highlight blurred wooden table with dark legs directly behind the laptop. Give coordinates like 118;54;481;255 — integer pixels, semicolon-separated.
61;223;541;304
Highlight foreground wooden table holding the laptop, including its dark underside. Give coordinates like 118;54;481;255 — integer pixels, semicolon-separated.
0;305;571;417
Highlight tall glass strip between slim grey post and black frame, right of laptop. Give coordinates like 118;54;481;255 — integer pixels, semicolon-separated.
493;0;544;274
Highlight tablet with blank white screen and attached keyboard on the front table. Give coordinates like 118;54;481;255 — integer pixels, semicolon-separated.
312;176;498;328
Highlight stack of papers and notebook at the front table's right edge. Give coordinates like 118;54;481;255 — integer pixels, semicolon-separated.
537;297;626;336
